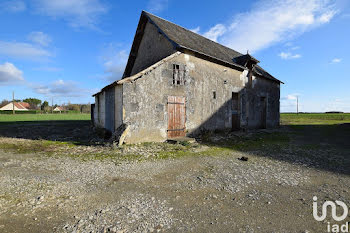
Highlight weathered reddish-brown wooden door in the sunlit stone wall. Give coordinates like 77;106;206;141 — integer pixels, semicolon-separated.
168;96;186;138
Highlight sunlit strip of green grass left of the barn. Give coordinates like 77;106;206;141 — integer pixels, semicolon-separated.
0;114;91;122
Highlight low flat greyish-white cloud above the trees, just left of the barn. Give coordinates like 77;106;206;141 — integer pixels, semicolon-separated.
30;79;93;97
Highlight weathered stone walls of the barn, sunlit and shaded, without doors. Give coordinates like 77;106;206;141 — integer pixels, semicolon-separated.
96;54;280;143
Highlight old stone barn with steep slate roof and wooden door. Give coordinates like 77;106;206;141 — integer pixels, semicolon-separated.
92;11;281;143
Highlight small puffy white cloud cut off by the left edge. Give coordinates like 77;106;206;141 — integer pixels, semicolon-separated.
0;62;24;85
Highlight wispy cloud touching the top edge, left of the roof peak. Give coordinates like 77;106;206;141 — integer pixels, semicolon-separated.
33;0;107;28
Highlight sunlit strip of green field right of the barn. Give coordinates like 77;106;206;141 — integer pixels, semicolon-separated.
281;113;350;125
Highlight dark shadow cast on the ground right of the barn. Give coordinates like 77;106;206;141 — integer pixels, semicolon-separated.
202;123;350;175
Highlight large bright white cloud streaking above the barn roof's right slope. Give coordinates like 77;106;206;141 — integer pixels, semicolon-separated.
209;0;337;52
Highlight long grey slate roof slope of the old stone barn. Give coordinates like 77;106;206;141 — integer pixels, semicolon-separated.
142;11;281;82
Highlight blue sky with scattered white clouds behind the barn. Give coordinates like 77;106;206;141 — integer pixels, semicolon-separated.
0;0;350;112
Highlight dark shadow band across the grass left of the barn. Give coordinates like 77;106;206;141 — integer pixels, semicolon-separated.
0;120;96;145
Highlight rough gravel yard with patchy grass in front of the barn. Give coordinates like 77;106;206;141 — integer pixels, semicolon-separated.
0;123;350;233
